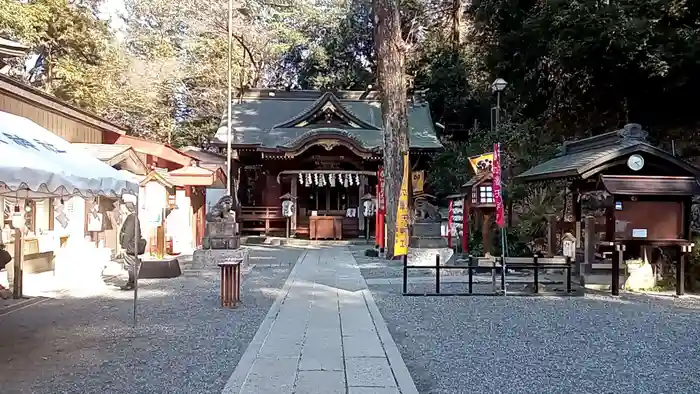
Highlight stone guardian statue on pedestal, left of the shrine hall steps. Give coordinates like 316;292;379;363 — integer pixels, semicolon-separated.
202;196;241;249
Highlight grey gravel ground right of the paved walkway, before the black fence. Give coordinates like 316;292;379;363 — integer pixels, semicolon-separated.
358;246;700;394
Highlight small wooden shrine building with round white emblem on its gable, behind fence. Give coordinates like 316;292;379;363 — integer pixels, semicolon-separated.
516;124;700;293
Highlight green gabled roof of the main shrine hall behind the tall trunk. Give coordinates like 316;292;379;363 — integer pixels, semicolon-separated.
215;90;442;150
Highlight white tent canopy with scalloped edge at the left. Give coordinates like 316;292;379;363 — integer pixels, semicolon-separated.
0;112;139;198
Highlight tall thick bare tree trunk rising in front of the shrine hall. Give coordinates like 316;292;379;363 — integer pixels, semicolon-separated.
372;0;410;259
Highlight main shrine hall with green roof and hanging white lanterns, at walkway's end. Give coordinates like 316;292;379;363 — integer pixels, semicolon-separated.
213;89;442;239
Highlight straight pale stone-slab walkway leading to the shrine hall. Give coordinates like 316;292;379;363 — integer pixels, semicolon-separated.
223;246;418;394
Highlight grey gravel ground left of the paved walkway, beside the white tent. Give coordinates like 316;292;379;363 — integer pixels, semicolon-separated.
0;247;300;394
